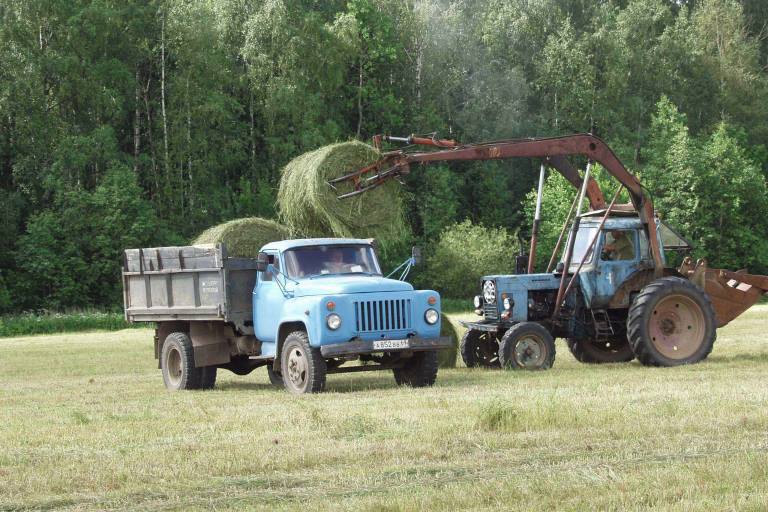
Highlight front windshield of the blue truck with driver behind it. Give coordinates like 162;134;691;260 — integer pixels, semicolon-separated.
285;245;381;279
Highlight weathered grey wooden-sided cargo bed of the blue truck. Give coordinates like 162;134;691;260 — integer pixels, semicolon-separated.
123;245;256;334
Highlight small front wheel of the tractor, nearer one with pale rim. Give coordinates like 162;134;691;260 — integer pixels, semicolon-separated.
499;322;555;370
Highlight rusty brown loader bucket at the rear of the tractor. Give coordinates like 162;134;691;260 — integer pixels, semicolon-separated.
679;258;768;327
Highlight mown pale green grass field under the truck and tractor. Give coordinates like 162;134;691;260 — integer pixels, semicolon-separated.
0;305;768;511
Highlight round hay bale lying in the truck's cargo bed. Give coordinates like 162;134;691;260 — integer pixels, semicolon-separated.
192;217;288;258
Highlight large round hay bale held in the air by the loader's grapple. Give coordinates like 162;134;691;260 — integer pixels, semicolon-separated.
277;141;405;242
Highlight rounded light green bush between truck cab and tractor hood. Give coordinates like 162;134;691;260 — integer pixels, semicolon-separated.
419;221;519;298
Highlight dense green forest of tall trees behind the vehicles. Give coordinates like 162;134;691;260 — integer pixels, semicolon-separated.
0;0;768;311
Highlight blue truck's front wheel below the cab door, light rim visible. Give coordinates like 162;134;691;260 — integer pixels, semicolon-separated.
280;331;326;395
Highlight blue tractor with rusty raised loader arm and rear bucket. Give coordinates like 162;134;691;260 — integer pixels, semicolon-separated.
329;133;768;369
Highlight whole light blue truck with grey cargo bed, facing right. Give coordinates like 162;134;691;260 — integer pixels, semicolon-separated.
123;238;453;394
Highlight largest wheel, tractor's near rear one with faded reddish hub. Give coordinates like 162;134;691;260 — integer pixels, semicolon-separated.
627;277;717;366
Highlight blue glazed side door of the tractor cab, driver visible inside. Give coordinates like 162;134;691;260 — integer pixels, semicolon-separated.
592;229;640;308
